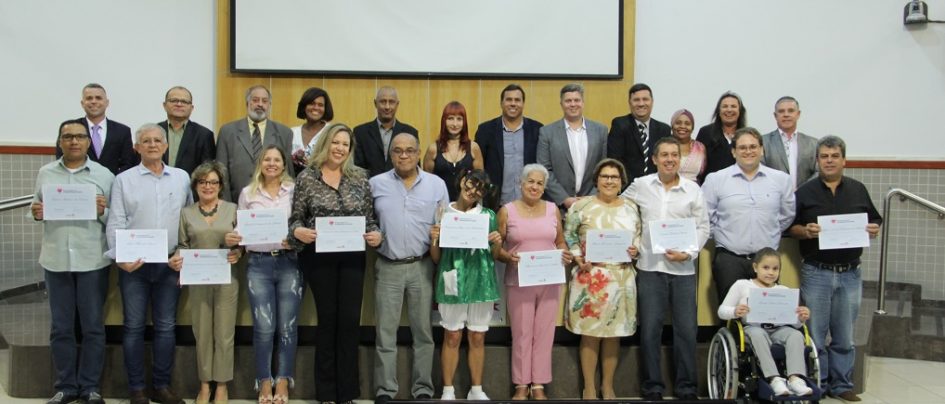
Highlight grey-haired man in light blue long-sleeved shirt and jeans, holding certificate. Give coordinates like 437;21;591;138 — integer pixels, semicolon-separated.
106;124;193;404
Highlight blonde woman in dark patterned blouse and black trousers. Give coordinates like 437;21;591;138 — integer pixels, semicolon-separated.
289;123;381;402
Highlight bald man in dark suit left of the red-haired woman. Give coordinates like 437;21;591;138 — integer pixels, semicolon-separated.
354;86;420;177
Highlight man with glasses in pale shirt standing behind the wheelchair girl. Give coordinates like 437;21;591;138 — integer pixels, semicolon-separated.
702;127;795;302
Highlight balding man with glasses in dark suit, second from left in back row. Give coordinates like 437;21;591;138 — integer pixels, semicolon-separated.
158;86;217;174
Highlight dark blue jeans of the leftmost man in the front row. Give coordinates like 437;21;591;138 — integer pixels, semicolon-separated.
44;267;108;395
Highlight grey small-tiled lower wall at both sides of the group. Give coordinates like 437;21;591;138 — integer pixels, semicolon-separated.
0;154;945;300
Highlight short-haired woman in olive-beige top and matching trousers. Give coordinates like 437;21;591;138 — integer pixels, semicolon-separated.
168;161;241;404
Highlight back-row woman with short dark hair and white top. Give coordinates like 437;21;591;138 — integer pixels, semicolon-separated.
292;87;335;174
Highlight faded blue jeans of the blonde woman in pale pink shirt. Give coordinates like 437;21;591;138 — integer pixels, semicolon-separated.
246;252;305;389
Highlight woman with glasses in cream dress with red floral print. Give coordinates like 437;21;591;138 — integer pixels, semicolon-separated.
564;159;641;400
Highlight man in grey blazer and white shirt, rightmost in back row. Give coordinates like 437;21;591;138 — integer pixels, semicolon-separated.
761;95;817;189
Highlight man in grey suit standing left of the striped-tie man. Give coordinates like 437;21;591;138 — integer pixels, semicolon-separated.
537;84;607;210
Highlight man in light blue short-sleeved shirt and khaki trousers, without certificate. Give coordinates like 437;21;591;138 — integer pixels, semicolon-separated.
371;133;449;404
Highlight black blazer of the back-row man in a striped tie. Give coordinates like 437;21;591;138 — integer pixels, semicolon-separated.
607;114;673;185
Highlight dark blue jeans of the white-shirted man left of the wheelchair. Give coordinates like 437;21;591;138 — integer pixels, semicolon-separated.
637;271;699;396
